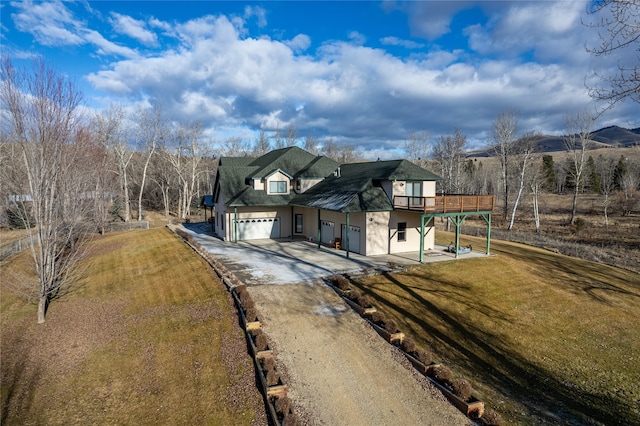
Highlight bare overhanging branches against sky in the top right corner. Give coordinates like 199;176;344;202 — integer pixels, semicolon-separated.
586;0;640;107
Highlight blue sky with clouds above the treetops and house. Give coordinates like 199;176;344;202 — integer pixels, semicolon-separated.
0;0;640;158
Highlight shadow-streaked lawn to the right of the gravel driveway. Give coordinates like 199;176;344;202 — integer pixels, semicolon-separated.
354;233;640;425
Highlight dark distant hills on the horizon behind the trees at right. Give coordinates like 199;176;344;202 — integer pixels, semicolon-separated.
468;126;640;157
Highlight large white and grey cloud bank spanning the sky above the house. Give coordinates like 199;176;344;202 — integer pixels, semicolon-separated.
47;4;638;158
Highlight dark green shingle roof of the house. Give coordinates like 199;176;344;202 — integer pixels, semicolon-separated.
216;147;442;212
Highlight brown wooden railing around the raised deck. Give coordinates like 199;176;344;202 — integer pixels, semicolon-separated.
393;195;494;213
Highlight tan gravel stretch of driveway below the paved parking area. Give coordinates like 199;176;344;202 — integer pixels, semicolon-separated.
249;284;472;426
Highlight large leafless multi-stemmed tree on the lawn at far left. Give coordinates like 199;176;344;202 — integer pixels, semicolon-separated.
0;59;94;323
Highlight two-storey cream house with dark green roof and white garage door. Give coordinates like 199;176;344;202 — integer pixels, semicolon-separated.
213;147;493;259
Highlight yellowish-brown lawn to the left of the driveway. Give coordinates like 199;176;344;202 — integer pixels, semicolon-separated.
0;228;264;425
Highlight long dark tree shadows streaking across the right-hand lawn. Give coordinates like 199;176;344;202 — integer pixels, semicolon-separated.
353;274;638;425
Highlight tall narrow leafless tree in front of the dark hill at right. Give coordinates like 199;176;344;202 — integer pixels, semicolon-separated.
564;111;595;225
